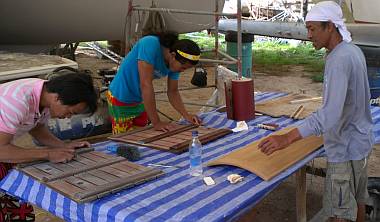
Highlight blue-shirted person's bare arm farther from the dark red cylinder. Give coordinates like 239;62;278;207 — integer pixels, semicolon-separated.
138;61;171;131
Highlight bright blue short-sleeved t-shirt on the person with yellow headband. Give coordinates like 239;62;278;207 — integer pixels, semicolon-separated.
109;36;179;103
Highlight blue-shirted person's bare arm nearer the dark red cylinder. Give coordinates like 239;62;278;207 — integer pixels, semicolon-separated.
167;78;201;125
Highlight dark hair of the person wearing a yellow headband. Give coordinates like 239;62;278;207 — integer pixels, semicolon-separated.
151;31;201;65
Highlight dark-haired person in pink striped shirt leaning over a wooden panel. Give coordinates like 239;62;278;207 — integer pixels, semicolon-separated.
0;73;98;221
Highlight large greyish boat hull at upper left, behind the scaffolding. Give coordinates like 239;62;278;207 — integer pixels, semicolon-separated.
0;0;224;44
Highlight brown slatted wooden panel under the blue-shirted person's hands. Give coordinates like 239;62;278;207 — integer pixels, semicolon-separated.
109;125;232;153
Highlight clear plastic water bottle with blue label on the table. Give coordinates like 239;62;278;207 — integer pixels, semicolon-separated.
189;130;203;176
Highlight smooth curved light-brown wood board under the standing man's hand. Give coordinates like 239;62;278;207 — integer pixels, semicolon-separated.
207;128;323;180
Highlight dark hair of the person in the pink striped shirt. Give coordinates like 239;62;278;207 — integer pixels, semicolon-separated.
45;72;98;114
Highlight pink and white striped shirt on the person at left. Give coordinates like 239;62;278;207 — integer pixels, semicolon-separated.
0;78;50;136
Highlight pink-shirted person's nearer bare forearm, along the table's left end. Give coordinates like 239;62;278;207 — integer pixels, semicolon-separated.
0;132;75;163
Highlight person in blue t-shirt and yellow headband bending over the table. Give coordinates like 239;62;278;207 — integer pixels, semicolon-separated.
107;33;200;134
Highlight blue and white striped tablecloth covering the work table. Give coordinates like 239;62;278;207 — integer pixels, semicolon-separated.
0;93;380;222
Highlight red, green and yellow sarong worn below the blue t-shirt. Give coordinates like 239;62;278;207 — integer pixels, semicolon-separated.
106;91;148;134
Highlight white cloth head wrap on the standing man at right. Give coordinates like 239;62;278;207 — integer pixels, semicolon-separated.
305;1;352;42
